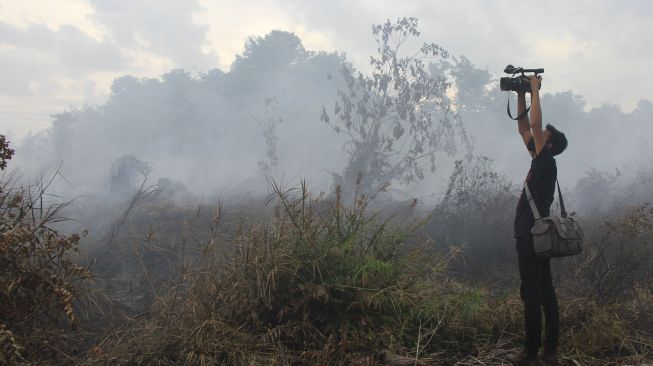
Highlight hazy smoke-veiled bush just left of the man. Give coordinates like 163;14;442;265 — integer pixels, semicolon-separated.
423;157;517;281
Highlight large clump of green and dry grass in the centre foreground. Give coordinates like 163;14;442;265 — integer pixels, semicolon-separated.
80;183;516;365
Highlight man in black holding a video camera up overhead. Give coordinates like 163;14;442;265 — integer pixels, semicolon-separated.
510;76;567;365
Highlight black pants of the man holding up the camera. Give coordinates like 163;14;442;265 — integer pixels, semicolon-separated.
517;239;560;356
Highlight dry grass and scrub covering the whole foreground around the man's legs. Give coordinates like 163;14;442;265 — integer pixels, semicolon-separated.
0;162;653;365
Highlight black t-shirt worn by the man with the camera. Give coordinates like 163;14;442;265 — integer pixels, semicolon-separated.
515;146;558;239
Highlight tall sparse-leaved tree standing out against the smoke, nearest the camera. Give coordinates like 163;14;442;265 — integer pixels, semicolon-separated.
321;18;469;192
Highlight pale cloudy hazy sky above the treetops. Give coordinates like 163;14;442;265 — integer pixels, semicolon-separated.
0;0;653;142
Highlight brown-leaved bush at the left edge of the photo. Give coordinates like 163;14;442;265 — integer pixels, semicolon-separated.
0;146;89;364
